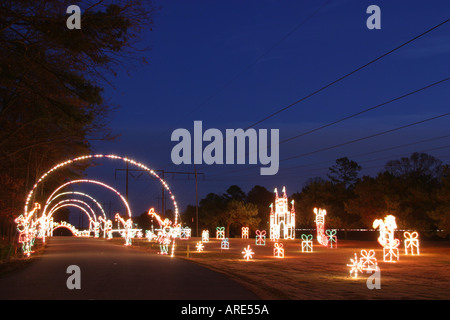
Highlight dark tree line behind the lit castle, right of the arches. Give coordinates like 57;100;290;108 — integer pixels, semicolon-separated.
182;152;450;237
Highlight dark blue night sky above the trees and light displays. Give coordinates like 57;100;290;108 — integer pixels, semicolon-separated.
85;0;450;219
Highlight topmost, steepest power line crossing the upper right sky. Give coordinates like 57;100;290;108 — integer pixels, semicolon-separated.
245;19;450;130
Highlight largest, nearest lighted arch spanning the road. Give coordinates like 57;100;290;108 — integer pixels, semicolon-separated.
24;154;179;224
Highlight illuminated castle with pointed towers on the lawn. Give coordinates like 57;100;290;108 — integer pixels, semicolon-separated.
270;187;295;240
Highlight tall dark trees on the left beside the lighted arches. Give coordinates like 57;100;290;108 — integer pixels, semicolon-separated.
0;0;155;241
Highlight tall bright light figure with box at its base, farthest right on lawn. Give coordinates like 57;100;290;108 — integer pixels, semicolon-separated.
373;215;400;262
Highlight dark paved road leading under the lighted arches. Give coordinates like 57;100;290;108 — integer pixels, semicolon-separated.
0;237;258;300
